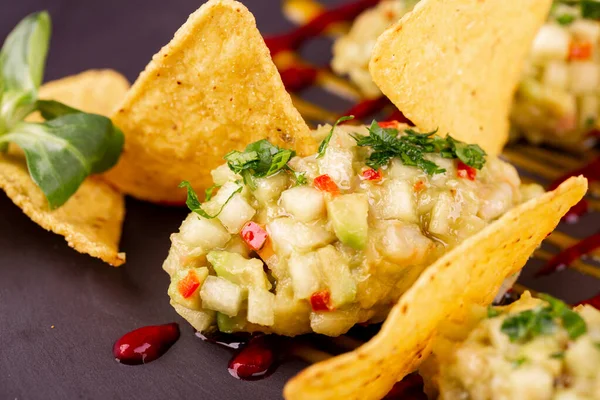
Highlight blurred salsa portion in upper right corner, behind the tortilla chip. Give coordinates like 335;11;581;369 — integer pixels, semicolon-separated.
511;1;600;147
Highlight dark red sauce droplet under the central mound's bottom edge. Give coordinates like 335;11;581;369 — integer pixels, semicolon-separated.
228;336;277;380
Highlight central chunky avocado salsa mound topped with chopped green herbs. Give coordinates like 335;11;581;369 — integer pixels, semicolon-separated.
164;118;542;336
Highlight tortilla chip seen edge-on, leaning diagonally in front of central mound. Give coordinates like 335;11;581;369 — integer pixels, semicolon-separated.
284;177;587;400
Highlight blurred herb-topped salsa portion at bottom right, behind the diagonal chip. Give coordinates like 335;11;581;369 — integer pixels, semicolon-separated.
433;293;600;400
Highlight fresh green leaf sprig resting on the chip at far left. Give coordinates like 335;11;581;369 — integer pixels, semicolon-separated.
0;12;124;209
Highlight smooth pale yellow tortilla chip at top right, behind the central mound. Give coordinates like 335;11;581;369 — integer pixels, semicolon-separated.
369;0;552;155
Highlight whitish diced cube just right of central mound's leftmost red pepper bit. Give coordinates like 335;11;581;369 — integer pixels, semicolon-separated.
200;275;245;317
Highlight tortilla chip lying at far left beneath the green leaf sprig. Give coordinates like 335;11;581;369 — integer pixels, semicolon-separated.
0;70;128;266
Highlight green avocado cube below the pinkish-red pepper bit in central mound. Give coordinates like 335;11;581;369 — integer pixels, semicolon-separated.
206;251;271;290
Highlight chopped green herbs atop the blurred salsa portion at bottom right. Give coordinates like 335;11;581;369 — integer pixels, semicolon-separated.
501;295;587;342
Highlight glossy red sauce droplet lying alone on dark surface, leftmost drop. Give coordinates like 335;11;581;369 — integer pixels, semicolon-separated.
113;323;179;365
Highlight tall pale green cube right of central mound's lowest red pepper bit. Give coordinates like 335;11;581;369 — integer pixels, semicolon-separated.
317;246;356;308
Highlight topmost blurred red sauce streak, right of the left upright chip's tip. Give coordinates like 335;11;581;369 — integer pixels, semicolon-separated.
265;0;381;56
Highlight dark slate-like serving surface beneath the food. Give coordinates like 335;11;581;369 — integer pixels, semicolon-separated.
0;0;599;400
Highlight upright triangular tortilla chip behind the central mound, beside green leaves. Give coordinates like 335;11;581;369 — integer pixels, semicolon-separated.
106;0;316;204
